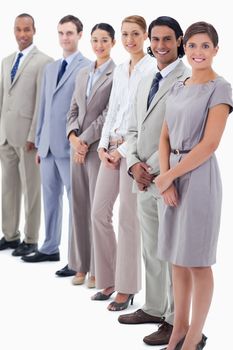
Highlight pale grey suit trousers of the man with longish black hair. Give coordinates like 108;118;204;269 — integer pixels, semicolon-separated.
137;184;174;324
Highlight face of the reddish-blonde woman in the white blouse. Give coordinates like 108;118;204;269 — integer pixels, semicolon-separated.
121;22;147;55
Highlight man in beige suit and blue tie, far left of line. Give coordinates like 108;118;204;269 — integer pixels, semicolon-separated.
0;13;52;256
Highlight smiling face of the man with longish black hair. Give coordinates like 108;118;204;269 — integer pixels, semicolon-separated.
150;25;181;69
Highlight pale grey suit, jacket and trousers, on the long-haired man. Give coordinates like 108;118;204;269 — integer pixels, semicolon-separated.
127;61;190;324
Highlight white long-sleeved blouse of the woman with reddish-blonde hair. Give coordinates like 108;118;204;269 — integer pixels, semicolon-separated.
98;55;157;157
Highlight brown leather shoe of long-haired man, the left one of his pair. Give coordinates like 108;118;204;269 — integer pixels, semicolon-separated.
118;309;164;324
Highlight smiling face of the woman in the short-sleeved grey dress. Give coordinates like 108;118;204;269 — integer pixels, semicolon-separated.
184;33;218;70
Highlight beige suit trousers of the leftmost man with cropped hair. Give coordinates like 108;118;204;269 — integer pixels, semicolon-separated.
0;142;41;243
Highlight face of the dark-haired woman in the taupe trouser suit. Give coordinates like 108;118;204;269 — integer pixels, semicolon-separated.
91;29;115;60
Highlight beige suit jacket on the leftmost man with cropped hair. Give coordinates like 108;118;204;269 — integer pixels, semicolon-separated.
0;46;53;147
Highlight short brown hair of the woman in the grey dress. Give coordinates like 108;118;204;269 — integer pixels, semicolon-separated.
183;21;218;47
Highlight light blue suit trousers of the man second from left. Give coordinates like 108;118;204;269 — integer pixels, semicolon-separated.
39;152;71;254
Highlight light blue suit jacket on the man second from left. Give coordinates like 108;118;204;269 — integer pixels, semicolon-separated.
36;52;91;158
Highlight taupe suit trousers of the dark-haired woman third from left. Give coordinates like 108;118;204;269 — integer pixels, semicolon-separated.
68;150;100;276
